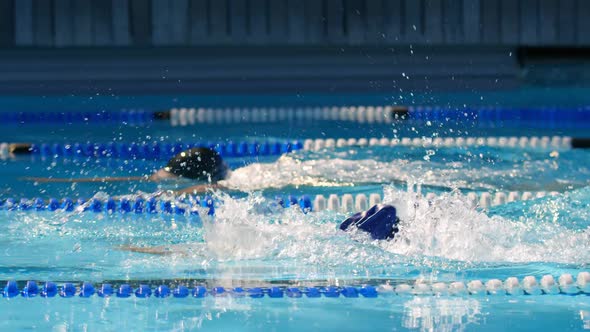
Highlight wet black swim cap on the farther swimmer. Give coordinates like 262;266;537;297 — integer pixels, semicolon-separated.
164;148;227;182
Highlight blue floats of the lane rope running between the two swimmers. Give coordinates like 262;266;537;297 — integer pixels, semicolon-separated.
0;195;313;215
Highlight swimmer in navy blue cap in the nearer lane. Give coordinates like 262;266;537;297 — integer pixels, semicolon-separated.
118;204;400;255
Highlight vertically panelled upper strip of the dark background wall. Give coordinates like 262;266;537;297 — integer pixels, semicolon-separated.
0;0;590;47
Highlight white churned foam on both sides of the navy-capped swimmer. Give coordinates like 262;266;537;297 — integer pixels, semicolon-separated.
164;188;590;267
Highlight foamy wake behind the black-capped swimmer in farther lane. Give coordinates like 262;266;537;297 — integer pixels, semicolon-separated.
222;147;590;191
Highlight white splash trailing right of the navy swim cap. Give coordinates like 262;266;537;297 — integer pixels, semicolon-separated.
381;188;590;264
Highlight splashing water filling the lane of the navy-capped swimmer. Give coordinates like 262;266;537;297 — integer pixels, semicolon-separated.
0;187;590;280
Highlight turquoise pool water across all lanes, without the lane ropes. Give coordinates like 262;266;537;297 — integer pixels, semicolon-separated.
0;103;590;331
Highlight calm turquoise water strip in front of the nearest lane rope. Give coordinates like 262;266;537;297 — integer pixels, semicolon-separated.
2;297;590;331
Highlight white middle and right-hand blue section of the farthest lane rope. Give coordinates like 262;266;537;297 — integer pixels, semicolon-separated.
165;105;590;128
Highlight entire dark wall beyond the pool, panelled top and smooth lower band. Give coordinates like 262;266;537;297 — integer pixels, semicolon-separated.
0;0;590;94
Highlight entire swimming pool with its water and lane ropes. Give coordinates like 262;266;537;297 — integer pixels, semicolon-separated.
0;99;590;331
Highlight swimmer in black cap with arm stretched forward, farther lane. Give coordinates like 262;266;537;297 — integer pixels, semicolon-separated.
23;147;231;194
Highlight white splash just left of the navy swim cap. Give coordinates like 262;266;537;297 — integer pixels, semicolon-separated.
203;195;366;262
